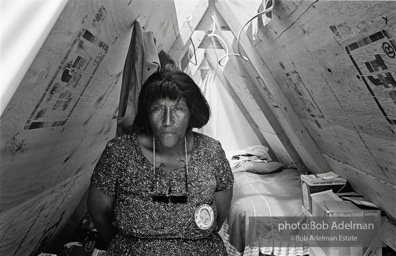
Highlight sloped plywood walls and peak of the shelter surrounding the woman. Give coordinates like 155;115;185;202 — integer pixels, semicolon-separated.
0;0;396;256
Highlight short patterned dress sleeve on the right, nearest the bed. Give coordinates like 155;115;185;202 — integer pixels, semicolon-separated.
216;142;234;192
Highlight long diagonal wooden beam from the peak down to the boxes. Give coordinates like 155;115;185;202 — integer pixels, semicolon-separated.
216;1;330;172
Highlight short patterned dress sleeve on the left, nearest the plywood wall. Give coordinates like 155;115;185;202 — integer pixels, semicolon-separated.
91;141;118;197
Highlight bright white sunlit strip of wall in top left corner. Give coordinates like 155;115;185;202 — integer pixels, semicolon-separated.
0;0;67;113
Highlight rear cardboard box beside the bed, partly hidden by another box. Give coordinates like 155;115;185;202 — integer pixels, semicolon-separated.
301;175;346;214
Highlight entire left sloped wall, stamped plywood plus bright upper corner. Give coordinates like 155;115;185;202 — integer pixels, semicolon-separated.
0;0;179;256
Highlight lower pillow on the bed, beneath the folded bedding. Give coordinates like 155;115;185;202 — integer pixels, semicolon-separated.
232;161;285;174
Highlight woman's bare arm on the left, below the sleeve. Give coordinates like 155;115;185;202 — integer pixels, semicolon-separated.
88;185;116;249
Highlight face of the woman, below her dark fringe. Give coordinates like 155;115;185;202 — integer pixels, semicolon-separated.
148;97;190;148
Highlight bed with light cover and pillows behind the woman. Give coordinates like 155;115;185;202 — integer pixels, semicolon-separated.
223;146;308;256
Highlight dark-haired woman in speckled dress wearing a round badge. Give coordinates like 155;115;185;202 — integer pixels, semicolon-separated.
88;70;233;256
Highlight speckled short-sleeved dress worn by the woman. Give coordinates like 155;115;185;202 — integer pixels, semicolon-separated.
91;132;233;256
